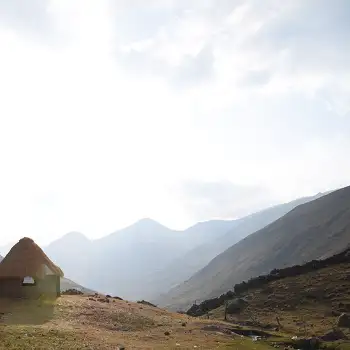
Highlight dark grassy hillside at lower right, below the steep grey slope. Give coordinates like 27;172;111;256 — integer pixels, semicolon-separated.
211;263;350;336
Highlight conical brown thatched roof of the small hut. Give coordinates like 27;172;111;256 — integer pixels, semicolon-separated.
0;237;63;278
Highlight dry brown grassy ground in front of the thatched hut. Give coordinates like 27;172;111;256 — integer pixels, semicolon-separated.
0;296;264;350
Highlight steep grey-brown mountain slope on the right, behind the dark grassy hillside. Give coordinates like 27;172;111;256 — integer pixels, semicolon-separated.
160;187;350;308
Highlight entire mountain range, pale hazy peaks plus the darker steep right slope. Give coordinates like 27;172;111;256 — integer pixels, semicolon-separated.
0;188;350;309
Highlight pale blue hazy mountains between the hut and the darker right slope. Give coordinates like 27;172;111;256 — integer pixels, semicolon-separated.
44;190;321;301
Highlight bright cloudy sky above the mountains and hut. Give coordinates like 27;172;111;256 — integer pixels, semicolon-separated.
0;0;350;245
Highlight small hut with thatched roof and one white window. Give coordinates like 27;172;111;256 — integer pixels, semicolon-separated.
0;237;63;299
